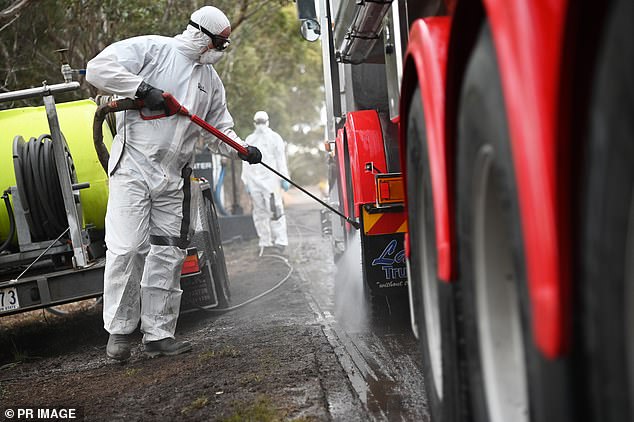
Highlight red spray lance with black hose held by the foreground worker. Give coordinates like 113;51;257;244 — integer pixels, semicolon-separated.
93;92;361;230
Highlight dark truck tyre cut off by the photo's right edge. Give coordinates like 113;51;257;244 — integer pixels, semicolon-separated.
575;0;634;422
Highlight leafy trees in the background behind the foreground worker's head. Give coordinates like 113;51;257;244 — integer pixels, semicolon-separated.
0;0;325;182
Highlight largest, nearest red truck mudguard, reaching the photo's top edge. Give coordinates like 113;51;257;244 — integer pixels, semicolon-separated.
484;0;570;358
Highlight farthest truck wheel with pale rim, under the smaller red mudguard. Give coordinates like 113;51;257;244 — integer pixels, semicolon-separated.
406;87;460;421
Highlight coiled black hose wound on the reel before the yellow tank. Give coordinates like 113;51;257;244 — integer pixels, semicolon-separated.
15;135;74;242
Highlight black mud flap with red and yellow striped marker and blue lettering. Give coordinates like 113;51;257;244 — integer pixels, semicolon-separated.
361;204;407;295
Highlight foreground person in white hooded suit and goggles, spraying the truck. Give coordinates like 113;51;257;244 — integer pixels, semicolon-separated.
86;6;261;360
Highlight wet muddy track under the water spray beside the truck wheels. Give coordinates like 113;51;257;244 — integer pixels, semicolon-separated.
288;193;429;421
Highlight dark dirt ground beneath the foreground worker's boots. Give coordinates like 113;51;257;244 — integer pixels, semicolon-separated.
0;201;364;421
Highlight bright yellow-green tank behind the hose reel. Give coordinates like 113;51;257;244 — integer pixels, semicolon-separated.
0;100;112;242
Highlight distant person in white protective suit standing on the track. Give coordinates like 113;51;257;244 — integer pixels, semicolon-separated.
242;111;289;255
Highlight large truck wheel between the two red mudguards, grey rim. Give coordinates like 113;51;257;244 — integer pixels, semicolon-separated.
456;24;571;422
